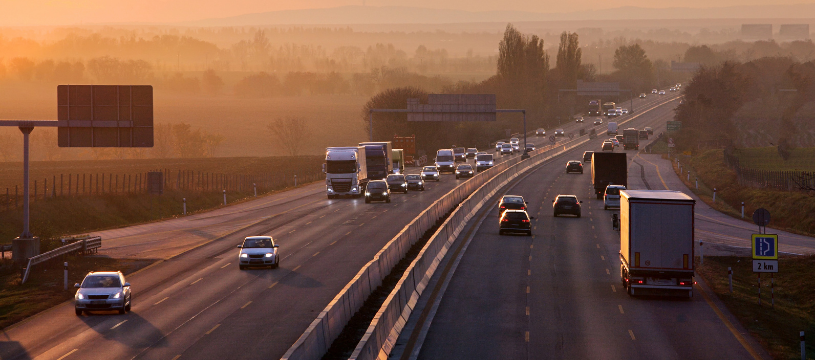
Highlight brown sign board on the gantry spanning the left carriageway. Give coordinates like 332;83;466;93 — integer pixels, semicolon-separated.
407;94;496;121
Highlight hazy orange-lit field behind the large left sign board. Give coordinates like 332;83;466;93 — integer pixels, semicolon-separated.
0;81;369;157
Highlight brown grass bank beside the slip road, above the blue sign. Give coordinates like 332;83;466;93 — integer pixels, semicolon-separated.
668;149;815;236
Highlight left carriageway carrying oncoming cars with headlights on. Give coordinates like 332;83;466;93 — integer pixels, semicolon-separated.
0;97;676;360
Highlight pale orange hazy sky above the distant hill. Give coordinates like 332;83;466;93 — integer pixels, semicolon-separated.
0;0;814;26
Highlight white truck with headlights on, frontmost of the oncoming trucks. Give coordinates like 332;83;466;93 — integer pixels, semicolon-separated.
322;146;368;199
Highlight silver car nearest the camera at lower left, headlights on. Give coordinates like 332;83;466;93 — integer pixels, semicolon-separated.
74;271;131;316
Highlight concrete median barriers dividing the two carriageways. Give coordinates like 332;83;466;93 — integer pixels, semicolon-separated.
282;98;675;360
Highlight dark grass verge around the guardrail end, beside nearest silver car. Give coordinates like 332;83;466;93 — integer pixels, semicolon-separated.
0;255;155;329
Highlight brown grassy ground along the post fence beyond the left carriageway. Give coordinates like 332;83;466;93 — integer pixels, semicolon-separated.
0;156;322;244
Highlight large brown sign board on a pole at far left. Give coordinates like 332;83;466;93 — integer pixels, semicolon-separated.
57;85;154;147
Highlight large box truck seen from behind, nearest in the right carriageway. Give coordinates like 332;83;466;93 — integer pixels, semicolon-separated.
613;190;695;297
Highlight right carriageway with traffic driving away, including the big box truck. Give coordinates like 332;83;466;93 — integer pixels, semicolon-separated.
400;95;780;359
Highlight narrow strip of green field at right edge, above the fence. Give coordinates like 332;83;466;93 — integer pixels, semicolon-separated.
734;146;814;171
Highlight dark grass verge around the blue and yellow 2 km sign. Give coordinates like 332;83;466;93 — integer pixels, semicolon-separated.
697;255;815;360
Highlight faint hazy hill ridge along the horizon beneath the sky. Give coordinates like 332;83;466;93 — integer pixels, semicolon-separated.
184;4;814;26
